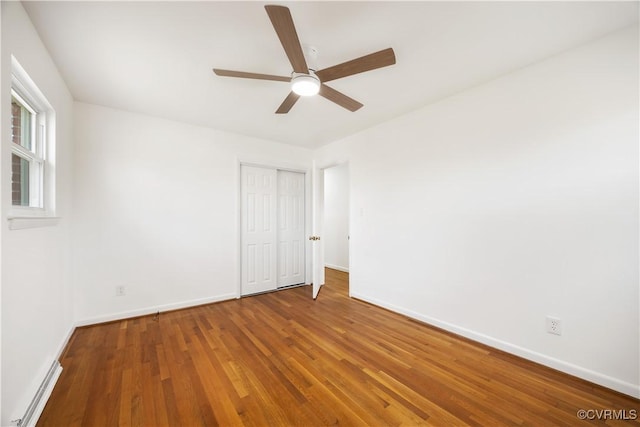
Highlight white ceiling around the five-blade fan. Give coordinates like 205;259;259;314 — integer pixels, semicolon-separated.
24;1;638;147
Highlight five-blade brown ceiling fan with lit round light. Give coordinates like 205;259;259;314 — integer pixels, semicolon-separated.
213;5;396;114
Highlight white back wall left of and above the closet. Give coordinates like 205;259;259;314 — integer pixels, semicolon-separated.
72;104;311;323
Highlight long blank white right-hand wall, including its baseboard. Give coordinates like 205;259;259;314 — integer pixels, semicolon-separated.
316;27;640;397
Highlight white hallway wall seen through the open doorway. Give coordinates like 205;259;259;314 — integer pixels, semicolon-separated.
323;163;349;271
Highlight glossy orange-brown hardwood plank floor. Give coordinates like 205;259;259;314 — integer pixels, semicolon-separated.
38;270;640;426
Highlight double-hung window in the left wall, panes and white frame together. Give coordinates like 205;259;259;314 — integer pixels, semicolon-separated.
10;58;55;221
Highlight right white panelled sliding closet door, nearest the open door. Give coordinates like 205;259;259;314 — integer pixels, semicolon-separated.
278;171;305;287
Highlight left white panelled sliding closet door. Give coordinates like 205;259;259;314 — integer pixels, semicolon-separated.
241;166;277;295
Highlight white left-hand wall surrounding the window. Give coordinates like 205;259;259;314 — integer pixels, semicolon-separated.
0;2;73;426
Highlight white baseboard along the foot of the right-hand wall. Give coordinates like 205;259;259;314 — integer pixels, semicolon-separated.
351;293;640;399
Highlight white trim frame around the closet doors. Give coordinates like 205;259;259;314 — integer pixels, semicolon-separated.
236;160;312;298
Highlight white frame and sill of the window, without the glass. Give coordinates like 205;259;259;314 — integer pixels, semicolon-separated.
8;56;55;224
